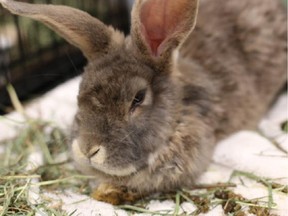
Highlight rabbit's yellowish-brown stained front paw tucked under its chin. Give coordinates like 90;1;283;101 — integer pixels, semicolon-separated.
91;184;140;205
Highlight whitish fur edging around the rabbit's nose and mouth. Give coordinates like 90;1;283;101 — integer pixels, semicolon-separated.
72;139;137;177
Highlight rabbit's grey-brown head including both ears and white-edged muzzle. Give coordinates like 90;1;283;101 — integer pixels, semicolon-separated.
0;0;198;177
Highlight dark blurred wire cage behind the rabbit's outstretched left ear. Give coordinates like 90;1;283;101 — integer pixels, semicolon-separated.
0;0;133;114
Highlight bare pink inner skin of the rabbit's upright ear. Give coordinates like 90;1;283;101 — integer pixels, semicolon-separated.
140;0;189;56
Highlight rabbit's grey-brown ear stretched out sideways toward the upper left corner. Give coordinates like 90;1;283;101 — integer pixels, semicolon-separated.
0;0;124;59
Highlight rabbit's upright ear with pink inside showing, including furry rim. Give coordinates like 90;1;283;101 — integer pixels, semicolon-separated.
131;0;198;60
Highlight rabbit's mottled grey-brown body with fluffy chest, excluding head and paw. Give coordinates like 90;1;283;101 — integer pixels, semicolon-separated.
89;0;287;196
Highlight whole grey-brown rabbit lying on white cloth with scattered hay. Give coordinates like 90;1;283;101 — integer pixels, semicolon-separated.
0;0;287;204
